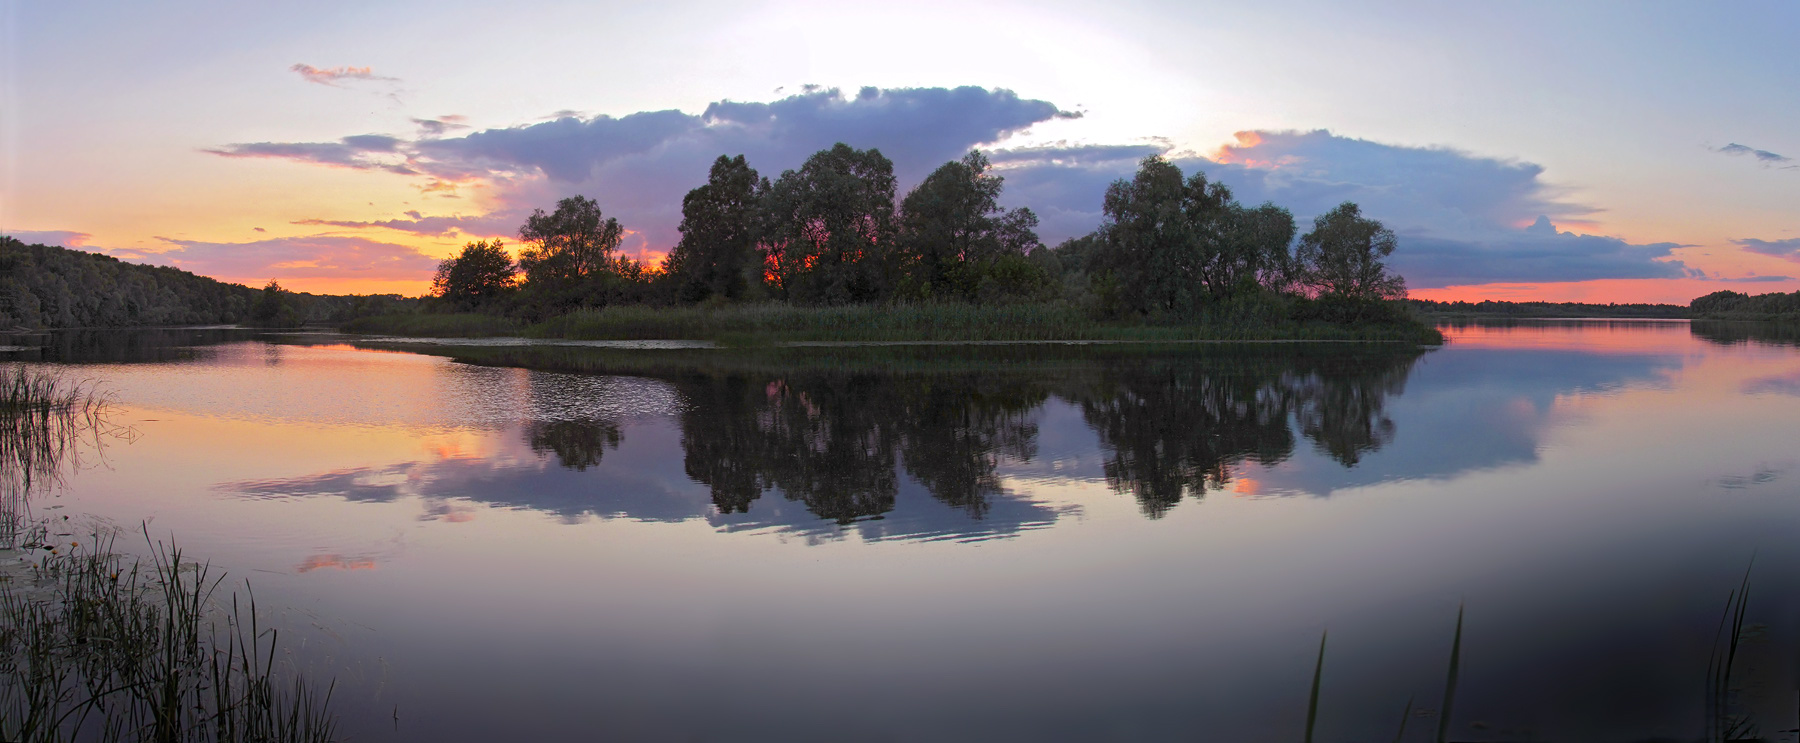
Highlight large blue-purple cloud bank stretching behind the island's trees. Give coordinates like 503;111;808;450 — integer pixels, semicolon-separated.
214;95;1690;288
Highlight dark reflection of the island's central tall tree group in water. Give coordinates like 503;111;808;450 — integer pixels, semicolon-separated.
679;371;1044;524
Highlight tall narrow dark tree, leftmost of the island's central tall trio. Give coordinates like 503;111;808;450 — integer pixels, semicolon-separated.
664;155;769;302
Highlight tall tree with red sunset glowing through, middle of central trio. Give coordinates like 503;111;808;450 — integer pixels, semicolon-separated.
758;142;895;304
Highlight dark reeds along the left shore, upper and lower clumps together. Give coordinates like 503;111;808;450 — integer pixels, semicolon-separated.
0;365;337;743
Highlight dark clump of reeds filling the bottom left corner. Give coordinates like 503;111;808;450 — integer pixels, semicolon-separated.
0;536;337;743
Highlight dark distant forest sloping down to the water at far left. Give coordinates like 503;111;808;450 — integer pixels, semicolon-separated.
0;236;418;329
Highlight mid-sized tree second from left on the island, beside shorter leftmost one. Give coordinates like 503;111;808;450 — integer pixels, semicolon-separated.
518;196;625;286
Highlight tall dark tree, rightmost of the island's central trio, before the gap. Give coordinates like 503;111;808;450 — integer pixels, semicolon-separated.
900;149;1039;297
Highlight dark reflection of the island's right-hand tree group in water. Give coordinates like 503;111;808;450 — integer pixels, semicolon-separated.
1071;354;1417;518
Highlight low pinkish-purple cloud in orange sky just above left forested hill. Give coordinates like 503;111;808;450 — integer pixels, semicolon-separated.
128;236;437;282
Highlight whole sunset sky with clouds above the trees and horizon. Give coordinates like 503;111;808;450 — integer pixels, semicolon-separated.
0;0;1800;304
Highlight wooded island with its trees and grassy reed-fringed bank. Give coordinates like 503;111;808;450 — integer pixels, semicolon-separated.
387;144;1442;344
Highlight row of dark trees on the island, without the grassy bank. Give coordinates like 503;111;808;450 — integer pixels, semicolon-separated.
432;142;1406;318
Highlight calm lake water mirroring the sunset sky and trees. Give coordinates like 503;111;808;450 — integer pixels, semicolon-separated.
4;322;1800;741
